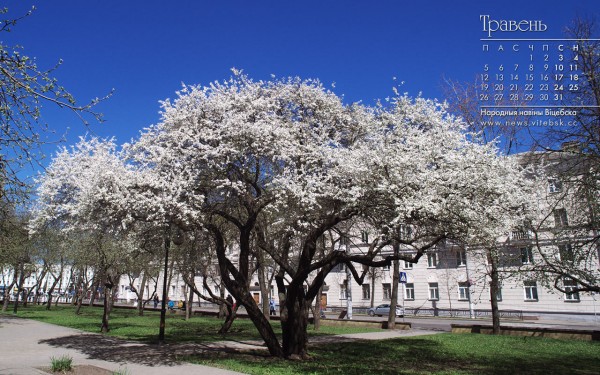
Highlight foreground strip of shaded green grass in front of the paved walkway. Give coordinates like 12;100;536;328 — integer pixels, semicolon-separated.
186;333;600;375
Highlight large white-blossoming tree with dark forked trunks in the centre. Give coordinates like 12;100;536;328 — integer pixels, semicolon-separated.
129;74;524;358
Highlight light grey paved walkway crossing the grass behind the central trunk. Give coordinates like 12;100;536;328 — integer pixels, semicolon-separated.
0;315;435;375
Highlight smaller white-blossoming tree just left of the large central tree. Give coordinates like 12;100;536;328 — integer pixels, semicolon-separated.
31;138;131;332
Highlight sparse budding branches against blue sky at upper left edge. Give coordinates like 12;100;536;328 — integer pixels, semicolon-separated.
0;8;109;201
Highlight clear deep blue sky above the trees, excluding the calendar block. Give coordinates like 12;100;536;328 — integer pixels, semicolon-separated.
0;0;600;181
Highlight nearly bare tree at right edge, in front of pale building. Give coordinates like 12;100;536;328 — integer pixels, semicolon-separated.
531;18;600;294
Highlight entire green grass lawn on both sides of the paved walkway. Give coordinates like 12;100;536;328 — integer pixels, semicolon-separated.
5;306;600;375
